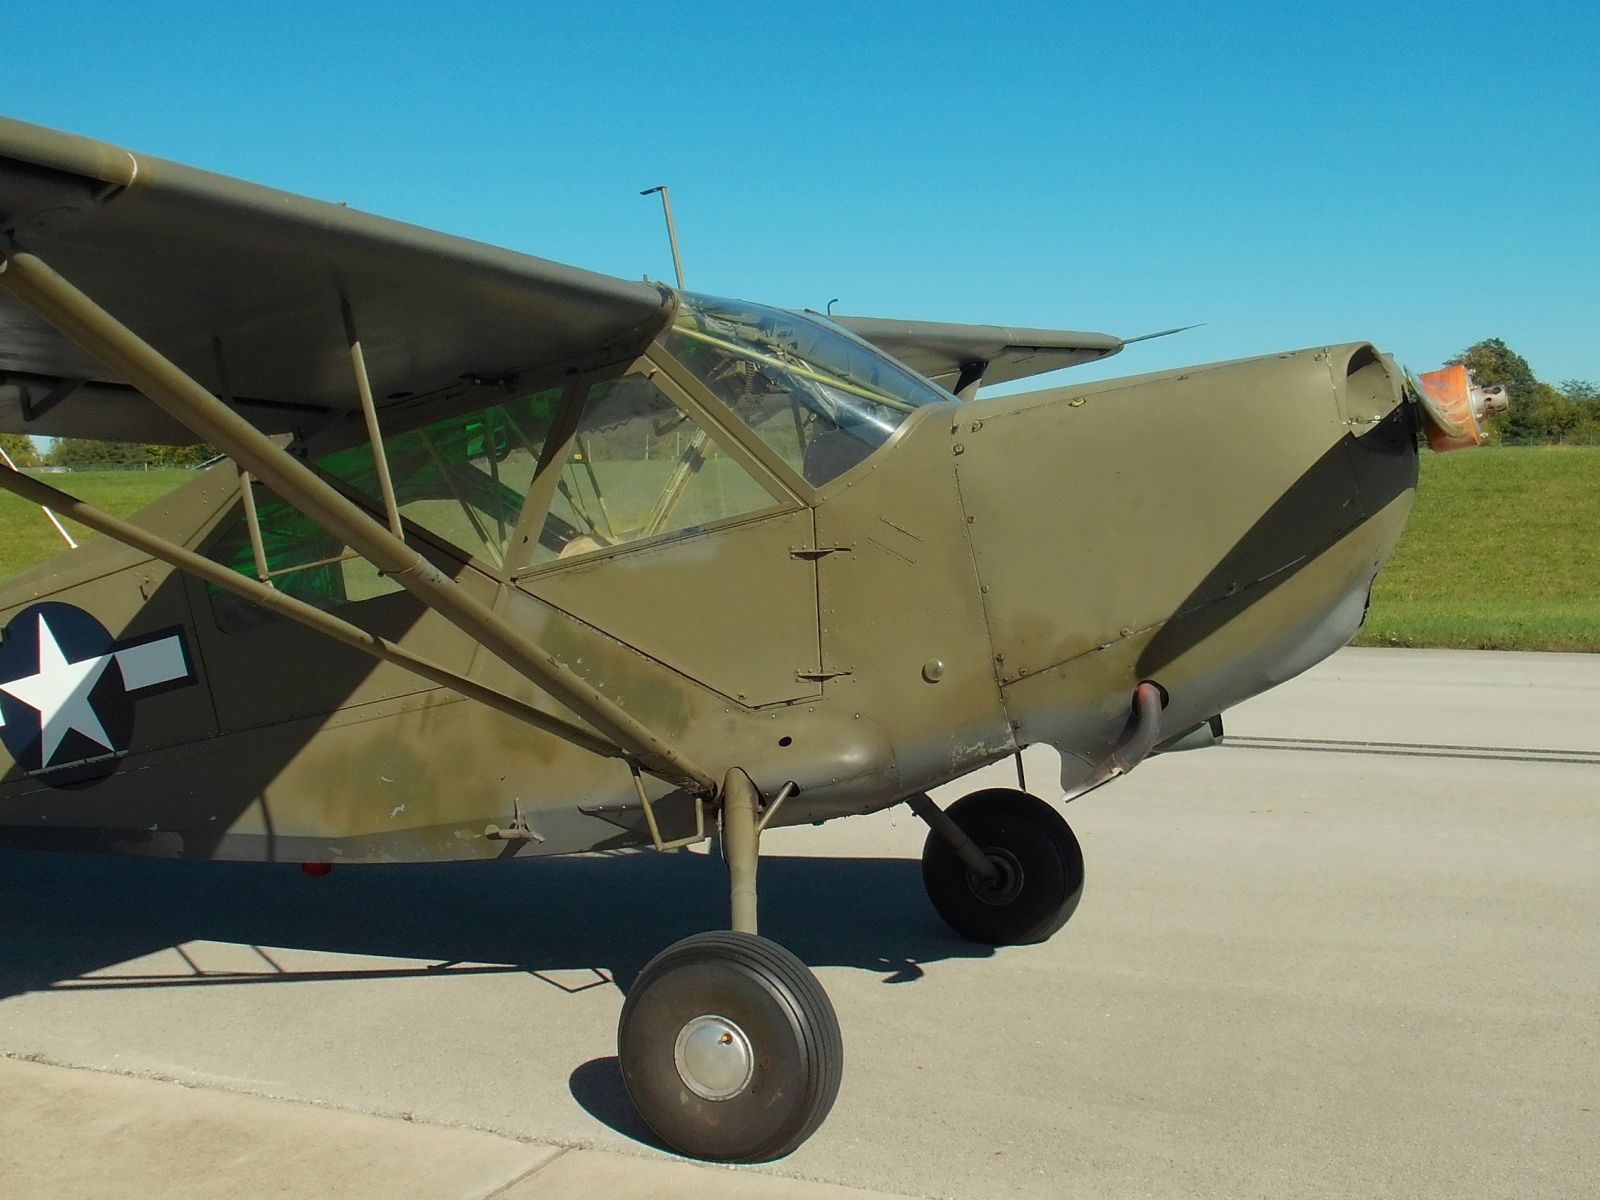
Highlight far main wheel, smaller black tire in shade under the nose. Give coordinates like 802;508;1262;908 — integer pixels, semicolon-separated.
922;787;1083;946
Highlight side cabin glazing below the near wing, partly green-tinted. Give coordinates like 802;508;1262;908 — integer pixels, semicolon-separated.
206;371;793;632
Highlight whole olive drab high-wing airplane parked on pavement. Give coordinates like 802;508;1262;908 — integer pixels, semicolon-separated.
0;120;1499;1160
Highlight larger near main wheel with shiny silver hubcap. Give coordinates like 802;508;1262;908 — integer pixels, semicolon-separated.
616;933;845;1163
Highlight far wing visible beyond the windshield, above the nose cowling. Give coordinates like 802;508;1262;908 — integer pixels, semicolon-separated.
834;317;1123;395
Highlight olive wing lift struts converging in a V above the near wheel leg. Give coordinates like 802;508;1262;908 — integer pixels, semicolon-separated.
0;240;720;810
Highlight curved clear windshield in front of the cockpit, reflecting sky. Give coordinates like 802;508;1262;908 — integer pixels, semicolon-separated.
661;294;952;486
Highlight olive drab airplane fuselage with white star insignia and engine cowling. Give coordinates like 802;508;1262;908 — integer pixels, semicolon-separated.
0;344;1416;861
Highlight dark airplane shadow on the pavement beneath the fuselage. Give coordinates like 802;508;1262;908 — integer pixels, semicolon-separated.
0;850;992;998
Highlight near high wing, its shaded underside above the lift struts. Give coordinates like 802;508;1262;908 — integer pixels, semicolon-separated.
0;118;672;443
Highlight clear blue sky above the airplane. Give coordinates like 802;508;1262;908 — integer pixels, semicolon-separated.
12;0;1600;390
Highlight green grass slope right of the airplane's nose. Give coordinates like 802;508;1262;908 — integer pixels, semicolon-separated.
1357;446;1600;651
